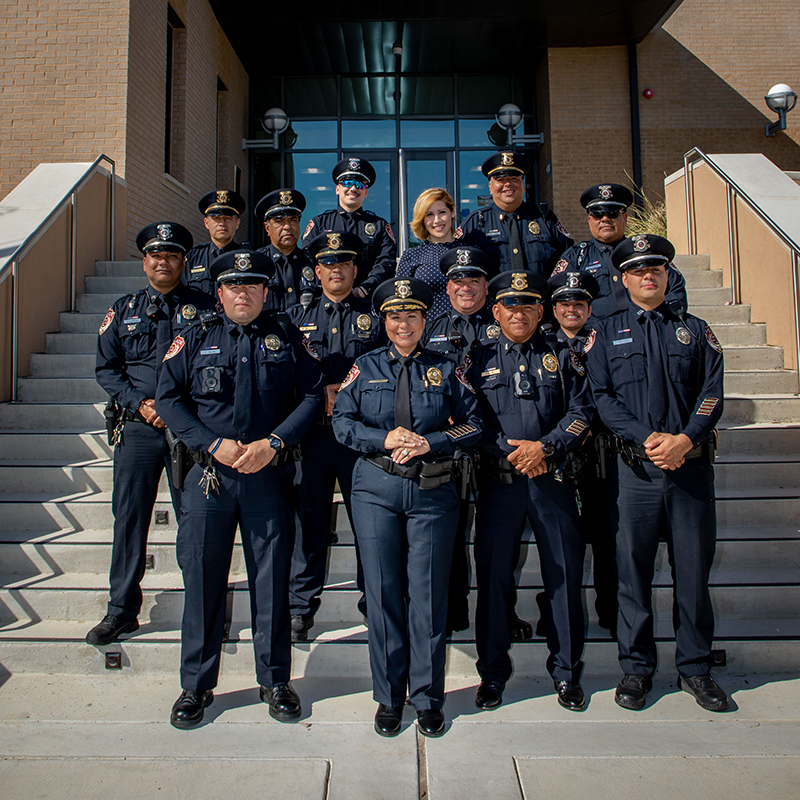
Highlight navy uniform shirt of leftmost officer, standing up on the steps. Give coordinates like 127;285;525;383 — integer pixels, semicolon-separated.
95;284;213;413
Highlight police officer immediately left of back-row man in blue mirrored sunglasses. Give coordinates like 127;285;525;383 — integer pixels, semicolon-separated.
256;189;319;311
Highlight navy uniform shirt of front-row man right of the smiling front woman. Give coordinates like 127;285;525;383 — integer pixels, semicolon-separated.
467;331;594;458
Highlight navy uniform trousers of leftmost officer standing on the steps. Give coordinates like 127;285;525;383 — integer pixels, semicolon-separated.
107;420;181;620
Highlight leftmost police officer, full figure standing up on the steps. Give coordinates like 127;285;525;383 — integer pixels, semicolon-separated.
86;222;211;645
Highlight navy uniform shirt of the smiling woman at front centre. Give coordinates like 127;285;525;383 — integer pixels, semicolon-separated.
333;346;483;460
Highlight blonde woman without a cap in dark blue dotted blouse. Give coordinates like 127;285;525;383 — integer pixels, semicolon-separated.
397;189;456;319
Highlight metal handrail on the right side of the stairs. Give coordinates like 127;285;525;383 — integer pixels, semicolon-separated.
683;147;800;394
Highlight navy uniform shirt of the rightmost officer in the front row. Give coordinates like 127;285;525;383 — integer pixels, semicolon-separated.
585;302;724;446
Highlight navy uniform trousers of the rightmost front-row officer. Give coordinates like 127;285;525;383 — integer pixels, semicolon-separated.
609;458;717;677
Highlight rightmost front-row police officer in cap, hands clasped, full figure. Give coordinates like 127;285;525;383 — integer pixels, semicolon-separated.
586;234;728;711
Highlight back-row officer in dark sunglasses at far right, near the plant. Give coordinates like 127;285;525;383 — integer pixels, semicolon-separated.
554;183;688;318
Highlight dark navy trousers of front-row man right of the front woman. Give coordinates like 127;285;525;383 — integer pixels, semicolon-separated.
474;474;586;683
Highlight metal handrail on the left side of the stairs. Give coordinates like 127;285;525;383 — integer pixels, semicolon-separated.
0;153;116;403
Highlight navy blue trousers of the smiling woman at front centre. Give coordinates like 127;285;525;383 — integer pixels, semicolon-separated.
352;460;458;711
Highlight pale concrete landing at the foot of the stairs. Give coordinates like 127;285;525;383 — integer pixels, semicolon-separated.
0;670;800;800
